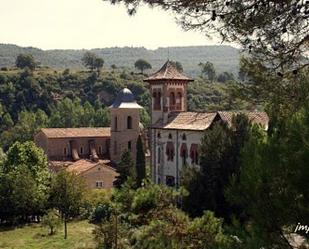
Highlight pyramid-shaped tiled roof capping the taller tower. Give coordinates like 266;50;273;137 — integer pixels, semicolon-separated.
144;60;193;82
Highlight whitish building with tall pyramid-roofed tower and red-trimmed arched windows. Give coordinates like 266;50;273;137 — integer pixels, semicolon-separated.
144;61;268;186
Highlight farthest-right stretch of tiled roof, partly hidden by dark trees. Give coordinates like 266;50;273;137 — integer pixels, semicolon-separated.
218;111;269;130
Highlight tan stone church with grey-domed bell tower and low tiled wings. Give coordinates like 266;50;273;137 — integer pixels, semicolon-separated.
34;88;146;188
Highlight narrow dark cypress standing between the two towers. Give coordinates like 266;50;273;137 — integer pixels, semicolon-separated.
136;135;146;187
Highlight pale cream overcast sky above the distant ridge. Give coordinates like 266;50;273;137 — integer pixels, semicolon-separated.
0;0;220;49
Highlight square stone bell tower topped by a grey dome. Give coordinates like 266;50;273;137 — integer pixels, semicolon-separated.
109;88;143;163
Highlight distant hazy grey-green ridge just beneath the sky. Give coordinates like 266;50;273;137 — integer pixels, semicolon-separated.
0;44;240;76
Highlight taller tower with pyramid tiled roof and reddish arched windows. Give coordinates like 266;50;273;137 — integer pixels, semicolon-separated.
144;60;193;125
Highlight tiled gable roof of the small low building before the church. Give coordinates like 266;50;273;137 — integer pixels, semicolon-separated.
66;159;115;175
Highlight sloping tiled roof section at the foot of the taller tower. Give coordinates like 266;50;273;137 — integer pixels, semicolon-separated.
153;112;217;131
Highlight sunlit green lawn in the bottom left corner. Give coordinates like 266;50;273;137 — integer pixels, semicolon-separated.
0;221;95;249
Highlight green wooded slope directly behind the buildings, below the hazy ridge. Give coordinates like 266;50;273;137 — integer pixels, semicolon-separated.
0;68;250;149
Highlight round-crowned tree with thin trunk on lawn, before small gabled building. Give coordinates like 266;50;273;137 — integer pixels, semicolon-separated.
50;170;86;239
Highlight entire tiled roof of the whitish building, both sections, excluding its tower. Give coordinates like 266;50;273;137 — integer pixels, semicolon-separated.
152;112;269;131
